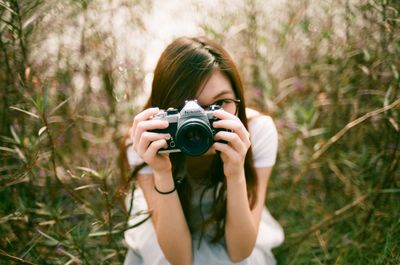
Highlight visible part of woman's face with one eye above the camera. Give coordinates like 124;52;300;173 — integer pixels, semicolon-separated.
197;70;237;115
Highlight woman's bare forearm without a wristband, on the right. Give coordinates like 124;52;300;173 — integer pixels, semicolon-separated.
225;171;258;261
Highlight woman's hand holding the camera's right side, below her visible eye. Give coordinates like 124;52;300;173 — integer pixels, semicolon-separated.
213;110;251;179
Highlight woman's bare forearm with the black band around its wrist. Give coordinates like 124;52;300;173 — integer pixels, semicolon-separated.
154;169;192;265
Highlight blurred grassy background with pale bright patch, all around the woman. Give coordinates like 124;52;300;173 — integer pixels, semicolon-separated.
0;0;400;264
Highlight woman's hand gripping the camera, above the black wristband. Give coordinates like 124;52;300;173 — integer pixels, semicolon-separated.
130;108;172;172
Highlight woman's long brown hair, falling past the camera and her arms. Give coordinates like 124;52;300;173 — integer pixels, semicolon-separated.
122;37;257;242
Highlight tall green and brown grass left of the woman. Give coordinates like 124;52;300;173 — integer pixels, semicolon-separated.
0;1;150;264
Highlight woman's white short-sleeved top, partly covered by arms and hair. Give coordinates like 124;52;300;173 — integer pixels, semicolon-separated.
124;111;284;265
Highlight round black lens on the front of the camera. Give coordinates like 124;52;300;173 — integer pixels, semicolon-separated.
176;119;213;156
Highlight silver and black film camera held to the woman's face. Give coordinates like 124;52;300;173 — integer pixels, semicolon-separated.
152;100;225;156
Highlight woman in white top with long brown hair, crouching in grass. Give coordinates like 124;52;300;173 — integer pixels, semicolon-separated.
125;35;283;265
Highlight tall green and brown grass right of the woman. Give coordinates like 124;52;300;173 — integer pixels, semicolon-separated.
223;1;400;264
